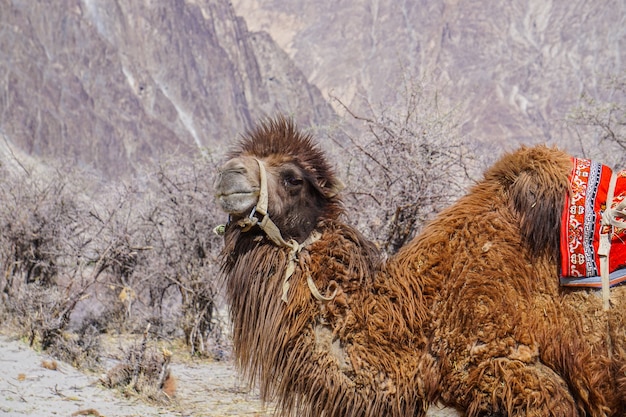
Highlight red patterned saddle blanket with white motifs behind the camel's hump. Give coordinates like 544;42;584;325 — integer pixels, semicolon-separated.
560;158;626;288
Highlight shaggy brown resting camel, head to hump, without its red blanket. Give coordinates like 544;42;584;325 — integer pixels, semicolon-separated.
215;117;626;417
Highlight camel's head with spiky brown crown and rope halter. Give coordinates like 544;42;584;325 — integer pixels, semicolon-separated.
215;117;342;242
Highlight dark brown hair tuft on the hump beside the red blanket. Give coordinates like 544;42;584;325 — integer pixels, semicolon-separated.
509;171;567;254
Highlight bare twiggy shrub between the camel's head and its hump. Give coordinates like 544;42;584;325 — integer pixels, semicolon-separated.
335;77;474;253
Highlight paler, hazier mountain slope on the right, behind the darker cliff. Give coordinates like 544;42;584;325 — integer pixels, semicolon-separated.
233;0;626;164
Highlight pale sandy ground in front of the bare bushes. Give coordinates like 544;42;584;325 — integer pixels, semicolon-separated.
0;335;459;417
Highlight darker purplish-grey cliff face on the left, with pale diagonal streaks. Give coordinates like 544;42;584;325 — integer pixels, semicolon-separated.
0;0;333;177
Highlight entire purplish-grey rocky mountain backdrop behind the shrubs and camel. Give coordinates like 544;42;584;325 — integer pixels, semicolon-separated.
0;0;626;177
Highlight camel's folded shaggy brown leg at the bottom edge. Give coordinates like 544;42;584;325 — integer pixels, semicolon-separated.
466;357;579;417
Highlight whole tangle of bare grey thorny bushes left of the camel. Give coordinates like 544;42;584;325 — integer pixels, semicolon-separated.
0;153;228;366
